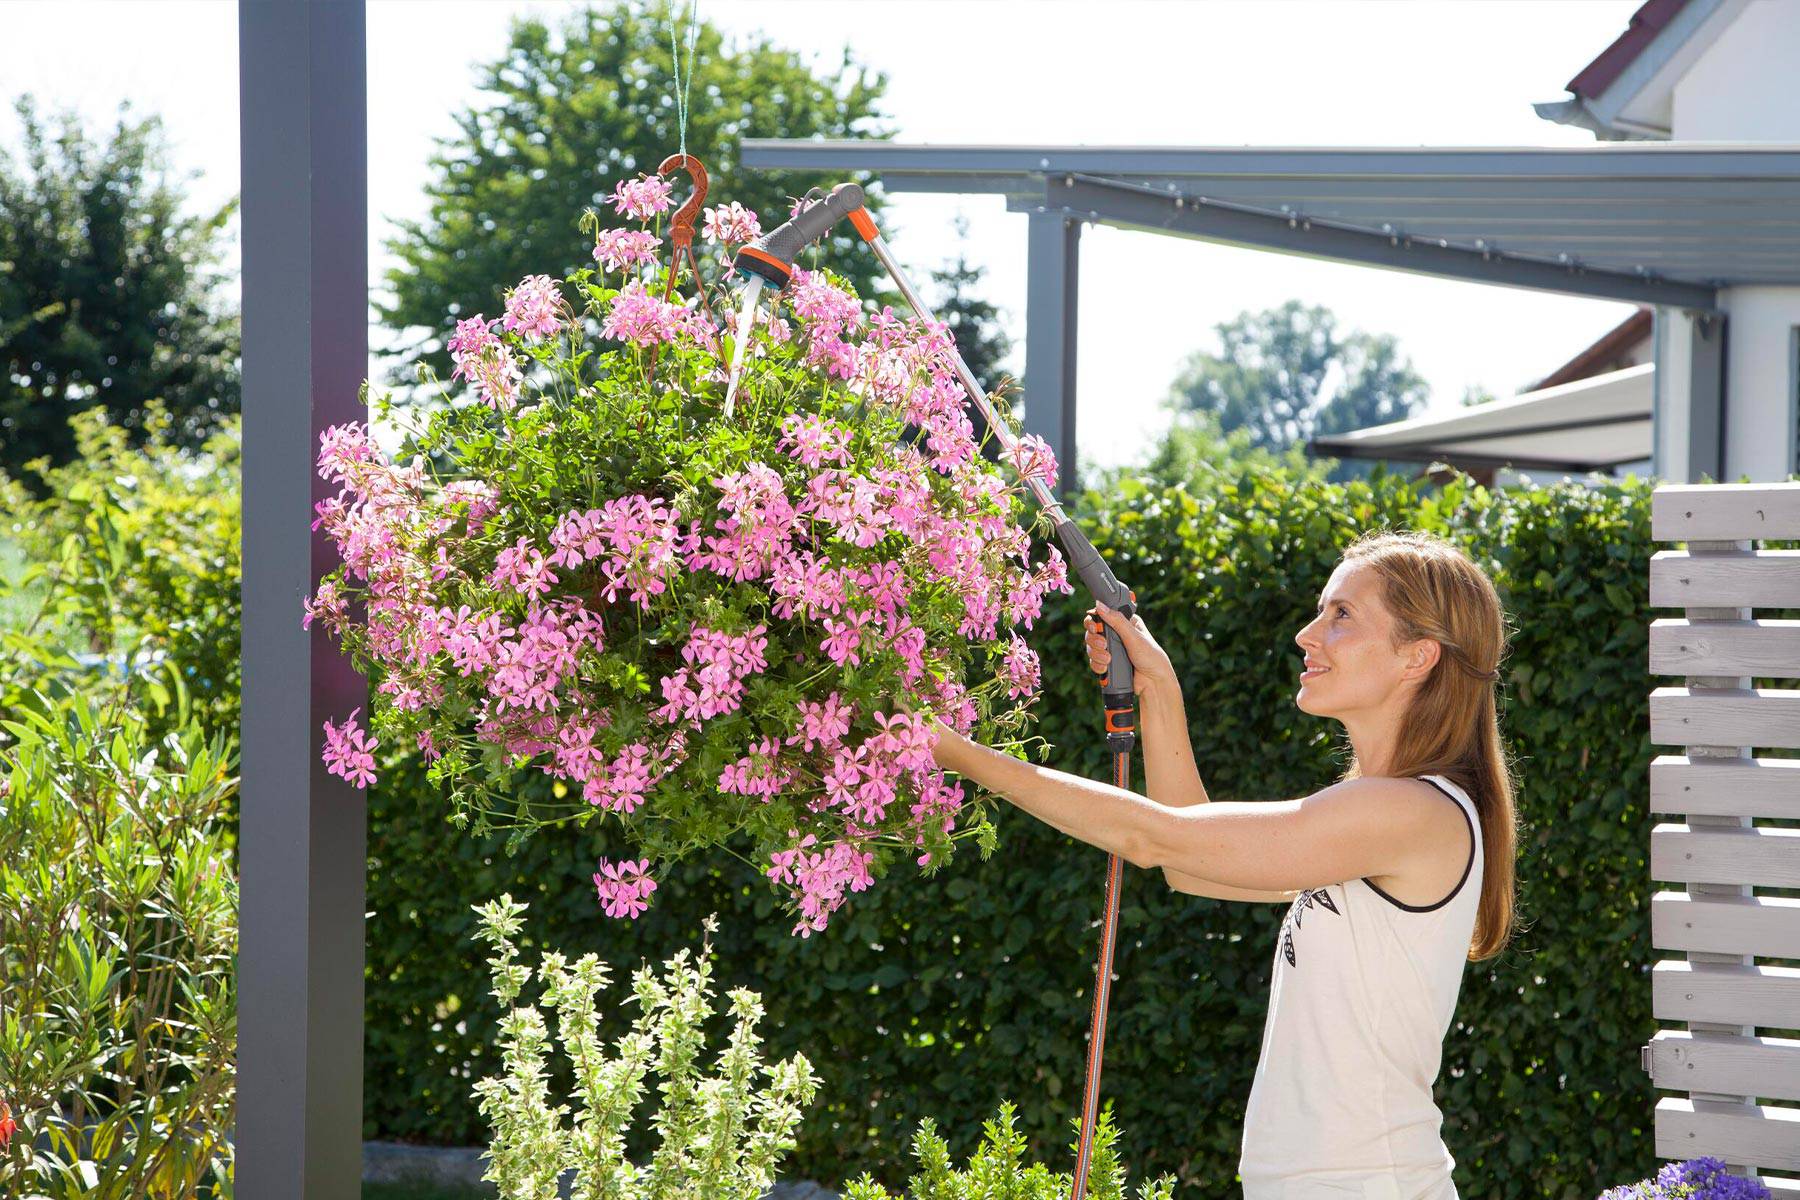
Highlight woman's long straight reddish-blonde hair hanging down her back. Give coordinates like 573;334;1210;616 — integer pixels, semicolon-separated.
1345;533;1517;959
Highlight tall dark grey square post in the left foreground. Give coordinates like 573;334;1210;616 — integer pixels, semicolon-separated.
236;0;369;1200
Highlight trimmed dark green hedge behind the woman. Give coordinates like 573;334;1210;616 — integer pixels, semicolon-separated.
364;475;1654;1200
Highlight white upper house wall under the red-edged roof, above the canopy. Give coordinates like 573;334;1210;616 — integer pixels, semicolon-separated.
1672;0;1800;142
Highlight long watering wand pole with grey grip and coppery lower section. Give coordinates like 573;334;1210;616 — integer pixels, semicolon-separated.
859;230;1138;1200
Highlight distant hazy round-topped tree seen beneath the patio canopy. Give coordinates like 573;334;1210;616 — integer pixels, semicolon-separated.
1170;300;1427;452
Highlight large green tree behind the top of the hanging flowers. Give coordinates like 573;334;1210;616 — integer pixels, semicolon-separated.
376;0;887;394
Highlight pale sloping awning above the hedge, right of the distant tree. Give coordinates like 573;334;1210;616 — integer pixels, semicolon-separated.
1307;363;1656;471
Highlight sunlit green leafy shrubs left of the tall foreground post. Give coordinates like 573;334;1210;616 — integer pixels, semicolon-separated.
0;444;238;1200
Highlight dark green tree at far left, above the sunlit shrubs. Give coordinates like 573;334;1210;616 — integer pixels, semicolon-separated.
0;95;239;475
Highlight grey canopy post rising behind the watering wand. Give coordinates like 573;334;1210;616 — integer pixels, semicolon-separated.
1024;209;1082;493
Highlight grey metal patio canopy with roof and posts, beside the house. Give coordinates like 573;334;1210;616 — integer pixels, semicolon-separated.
743;139;1800;482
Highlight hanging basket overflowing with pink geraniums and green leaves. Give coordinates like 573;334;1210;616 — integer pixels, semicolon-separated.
306;170;1069;936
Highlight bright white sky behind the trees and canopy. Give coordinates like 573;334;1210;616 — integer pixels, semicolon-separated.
0;0;1636;464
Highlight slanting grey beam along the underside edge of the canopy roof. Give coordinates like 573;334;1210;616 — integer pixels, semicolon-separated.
1044;175;1717;311
